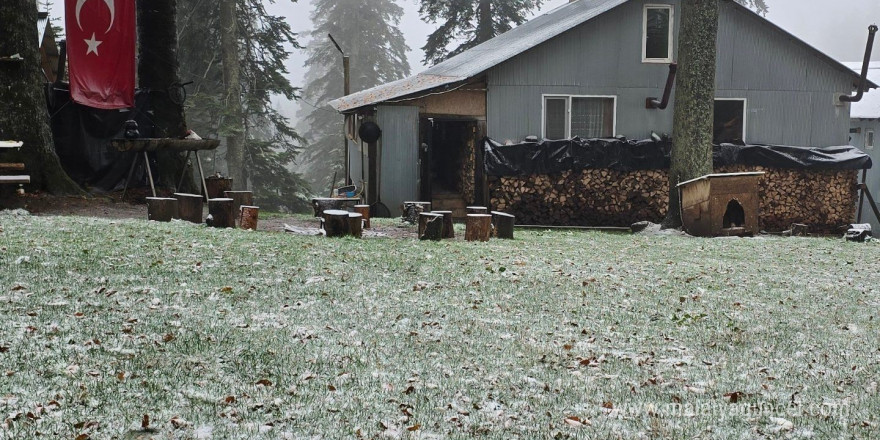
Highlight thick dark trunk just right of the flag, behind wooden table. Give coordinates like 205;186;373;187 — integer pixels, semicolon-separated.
137;0;196;192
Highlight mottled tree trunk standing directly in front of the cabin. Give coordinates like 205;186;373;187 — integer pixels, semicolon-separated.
663;0;718;228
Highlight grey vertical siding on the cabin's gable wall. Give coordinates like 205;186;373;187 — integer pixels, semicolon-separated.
487;0;853;147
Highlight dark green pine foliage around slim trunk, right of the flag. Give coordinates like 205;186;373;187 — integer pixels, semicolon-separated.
177;0;308;211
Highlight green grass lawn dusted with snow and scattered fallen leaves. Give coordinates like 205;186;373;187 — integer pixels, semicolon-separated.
0;214;880;439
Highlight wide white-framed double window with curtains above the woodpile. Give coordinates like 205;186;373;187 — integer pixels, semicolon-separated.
542;95;617;140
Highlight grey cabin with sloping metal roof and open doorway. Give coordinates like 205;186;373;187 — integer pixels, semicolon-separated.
331;0;877;212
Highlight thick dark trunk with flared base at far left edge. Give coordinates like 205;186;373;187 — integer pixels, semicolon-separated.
0;0;83;195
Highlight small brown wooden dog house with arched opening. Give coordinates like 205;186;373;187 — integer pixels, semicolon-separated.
678;172;764;237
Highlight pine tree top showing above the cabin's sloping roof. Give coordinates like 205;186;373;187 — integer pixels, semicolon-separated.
419;0;543;65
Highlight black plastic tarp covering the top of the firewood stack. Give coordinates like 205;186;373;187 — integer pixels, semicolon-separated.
483;138;872;177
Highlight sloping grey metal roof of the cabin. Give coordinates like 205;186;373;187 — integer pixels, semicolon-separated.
329;0;877;112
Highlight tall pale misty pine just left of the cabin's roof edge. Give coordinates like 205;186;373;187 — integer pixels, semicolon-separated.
300;0;410;193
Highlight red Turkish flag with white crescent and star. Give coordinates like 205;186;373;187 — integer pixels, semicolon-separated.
65;0;136;109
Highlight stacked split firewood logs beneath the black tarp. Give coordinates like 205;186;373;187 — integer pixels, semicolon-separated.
489;166;857;232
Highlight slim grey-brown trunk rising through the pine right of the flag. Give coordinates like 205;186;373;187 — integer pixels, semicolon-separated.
220;0;247;189
